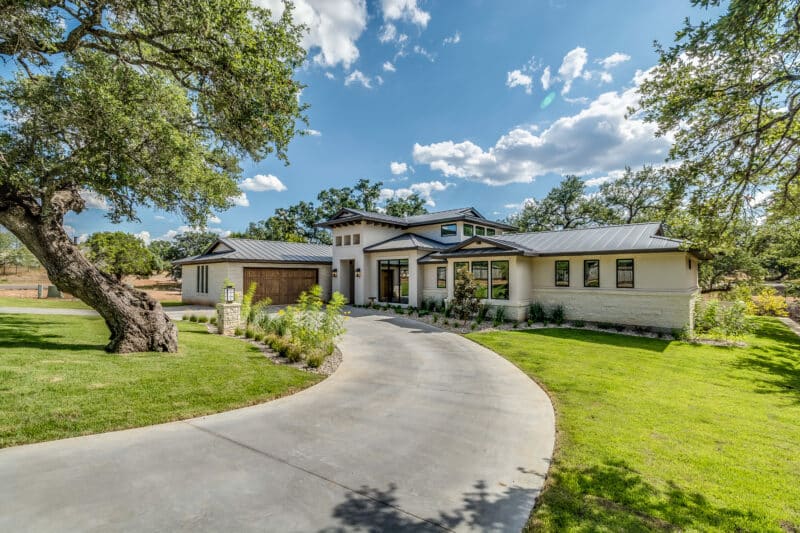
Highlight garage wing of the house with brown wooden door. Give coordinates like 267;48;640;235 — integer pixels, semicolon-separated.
174;239;332;304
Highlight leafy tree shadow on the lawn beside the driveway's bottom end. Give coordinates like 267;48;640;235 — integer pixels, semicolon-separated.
529;461;763;531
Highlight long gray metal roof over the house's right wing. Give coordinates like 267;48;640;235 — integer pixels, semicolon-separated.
437;222;686;257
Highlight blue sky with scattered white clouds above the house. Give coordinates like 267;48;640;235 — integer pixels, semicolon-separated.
62;0;710;243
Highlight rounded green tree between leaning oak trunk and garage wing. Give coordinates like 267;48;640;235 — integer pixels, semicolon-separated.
84;231;159;280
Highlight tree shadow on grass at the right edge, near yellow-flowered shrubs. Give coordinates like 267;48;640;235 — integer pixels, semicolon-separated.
733;319;800;402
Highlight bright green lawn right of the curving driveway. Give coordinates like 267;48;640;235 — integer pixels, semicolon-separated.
467;319;800;531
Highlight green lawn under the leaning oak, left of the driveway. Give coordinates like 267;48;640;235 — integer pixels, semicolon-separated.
0;314;321;447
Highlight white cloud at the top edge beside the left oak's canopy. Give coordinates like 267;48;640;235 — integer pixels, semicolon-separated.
256;0;367;68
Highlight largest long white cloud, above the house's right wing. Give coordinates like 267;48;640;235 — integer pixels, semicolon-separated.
413;75;672;185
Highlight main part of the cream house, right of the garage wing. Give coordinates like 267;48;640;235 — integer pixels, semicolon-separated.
321;208;698;329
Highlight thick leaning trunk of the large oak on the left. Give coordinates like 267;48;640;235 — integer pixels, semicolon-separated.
0;206;178;353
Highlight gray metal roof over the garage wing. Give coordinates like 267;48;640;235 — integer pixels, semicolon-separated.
173;238;333;265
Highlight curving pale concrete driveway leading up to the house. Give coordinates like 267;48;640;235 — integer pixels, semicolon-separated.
0;315;554;532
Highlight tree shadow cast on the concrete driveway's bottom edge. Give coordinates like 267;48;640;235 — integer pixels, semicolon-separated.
322;481;538;533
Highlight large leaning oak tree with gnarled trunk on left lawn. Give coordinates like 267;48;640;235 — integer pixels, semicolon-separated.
0;0;305;352
